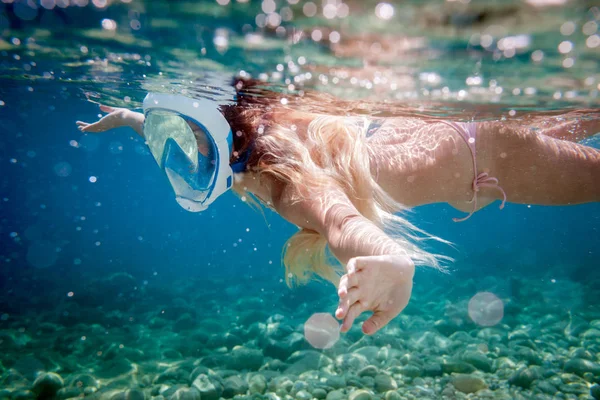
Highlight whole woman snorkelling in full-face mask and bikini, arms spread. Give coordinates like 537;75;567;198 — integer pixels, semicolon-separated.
77;80;600;334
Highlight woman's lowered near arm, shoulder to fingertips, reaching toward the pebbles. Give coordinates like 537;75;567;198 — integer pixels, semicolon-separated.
274;187;415;334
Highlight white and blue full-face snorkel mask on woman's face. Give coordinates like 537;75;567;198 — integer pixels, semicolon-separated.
144;93;245;212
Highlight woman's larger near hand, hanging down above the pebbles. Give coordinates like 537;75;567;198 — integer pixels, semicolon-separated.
335;255;415;335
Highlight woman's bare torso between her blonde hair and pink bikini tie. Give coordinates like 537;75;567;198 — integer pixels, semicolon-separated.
367;118;488;211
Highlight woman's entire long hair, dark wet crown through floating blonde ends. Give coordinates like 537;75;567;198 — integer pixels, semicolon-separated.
222;79;449;286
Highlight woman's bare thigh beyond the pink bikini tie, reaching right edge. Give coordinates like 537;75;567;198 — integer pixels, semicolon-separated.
477;122;600;205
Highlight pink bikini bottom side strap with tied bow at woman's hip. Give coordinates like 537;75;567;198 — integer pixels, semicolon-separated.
440;121;506;222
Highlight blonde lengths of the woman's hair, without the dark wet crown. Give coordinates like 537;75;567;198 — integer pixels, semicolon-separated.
237;115;451;286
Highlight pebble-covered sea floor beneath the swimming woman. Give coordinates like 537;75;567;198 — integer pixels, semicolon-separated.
0;273;600;400
